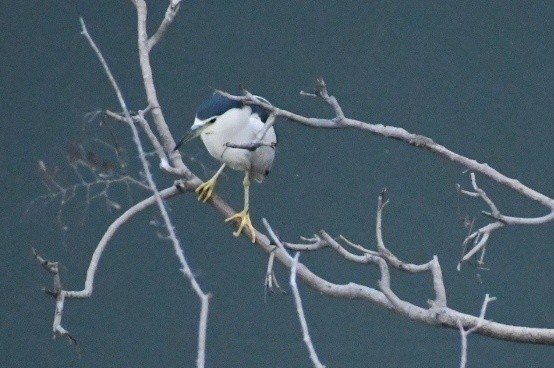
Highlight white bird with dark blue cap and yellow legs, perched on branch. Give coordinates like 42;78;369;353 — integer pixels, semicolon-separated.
174;93;277;243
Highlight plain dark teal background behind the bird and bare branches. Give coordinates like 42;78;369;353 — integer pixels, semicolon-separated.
0;1;554;367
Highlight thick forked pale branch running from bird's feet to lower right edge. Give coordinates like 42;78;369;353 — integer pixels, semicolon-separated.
260;196;554;345
